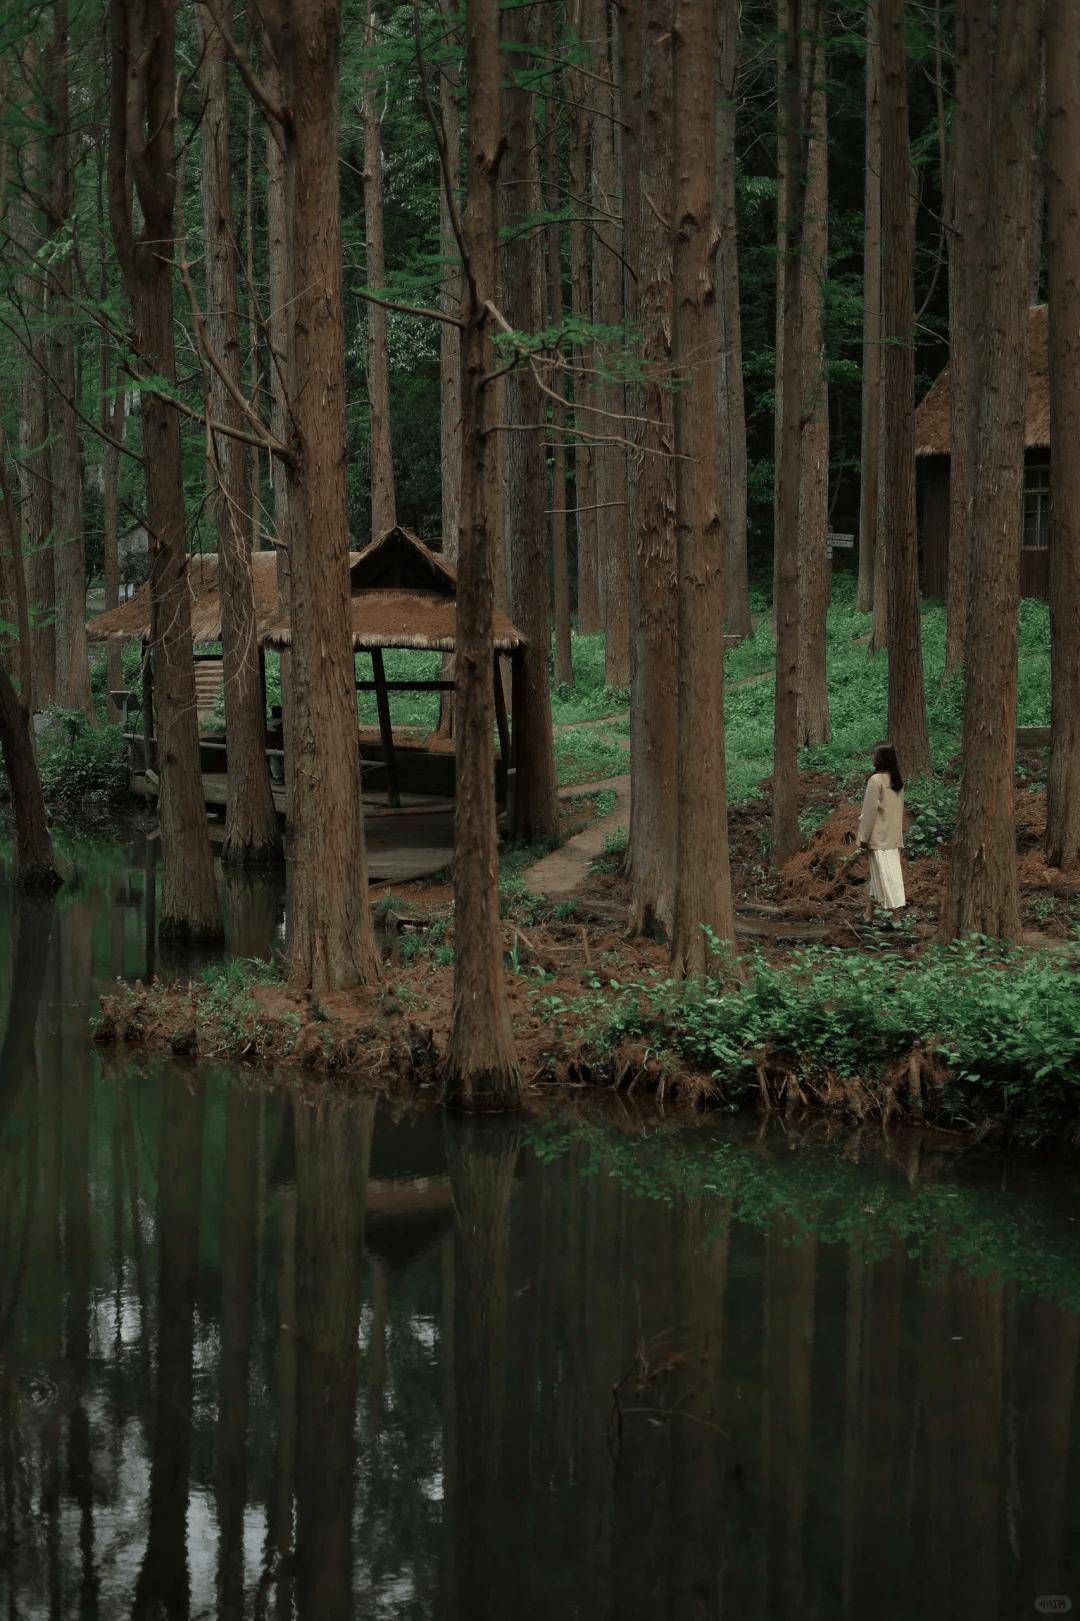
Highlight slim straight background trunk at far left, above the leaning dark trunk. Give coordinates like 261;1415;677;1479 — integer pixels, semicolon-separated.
15;39;57;710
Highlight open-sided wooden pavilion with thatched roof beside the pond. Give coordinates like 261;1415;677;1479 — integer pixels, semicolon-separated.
88;527;525;814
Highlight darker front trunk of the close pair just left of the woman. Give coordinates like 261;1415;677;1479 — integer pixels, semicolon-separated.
772;0;806;867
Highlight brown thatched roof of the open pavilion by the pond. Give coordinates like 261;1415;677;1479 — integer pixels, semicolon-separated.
86;527;525;653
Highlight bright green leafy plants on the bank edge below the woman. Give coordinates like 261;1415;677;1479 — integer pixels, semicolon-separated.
538;939;1080;1136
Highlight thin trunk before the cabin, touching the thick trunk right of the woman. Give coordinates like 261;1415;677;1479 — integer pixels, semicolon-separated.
945;0;992;678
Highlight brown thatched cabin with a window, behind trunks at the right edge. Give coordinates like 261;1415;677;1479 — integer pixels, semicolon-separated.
915;305;1051;598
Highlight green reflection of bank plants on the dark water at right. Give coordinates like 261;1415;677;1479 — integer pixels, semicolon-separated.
525;1122;1080;1311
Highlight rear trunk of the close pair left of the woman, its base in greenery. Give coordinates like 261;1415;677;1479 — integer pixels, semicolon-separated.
798;15;832;744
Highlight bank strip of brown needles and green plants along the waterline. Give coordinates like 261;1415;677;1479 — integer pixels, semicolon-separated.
96;917;1080;1149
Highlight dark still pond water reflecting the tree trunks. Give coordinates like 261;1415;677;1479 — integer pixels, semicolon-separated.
0;845;1080;1621
